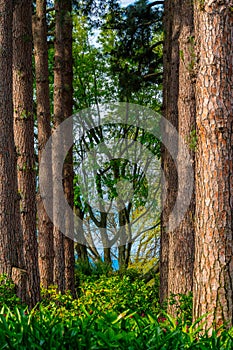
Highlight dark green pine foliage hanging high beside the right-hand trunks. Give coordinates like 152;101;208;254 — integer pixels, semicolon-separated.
99;0;162;107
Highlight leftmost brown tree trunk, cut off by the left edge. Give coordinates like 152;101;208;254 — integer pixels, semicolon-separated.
0;0;17;277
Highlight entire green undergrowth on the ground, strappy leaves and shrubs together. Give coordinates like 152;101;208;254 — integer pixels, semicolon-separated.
0;275;233;350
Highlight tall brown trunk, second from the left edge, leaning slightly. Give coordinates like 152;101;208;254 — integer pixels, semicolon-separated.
13;0;40;307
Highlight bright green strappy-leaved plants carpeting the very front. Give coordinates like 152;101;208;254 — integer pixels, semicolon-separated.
0;305;233;350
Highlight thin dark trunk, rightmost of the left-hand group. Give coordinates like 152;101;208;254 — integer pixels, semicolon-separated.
63;0;75;295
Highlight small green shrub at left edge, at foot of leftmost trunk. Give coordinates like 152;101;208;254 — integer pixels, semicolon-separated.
0;274;20;307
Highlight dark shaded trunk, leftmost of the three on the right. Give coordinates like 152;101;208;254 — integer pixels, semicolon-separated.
160;0;180;303
